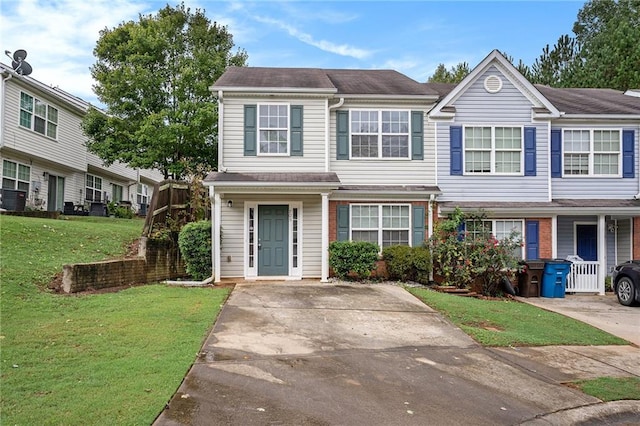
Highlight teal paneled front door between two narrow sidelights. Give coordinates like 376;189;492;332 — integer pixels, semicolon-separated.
258;206;289;276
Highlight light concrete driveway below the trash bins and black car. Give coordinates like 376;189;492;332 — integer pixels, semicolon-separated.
518;293;640;346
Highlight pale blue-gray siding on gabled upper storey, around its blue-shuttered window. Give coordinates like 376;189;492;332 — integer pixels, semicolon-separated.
433;67;549;202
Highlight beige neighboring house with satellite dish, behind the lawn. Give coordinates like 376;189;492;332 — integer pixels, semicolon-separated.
0;64;162;216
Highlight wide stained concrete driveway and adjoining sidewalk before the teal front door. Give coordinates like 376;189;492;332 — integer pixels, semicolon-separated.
155;282;640;425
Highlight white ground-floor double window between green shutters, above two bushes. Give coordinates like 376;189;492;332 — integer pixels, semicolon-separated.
351;204;411;248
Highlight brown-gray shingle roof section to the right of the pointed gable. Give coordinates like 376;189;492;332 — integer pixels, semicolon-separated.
535;84;640;115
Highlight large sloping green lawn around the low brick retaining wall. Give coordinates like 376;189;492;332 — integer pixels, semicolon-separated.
0;216;228;425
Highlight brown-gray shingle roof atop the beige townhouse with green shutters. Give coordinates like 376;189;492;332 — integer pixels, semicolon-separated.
212;67;438;97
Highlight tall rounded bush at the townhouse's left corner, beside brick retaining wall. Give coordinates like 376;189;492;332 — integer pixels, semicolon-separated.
178;220;211;280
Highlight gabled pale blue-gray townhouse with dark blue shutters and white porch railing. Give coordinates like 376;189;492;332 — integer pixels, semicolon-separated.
427;51;640;293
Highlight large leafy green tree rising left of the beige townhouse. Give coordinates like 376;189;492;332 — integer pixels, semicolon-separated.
82;3;247;179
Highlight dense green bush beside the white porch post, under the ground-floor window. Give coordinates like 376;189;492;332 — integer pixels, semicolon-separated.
329;241;379;279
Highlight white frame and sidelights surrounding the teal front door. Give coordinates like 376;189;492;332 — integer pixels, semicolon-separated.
245;200;304;279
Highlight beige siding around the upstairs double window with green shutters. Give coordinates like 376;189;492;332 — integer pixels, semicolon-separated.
329;102;436;185
